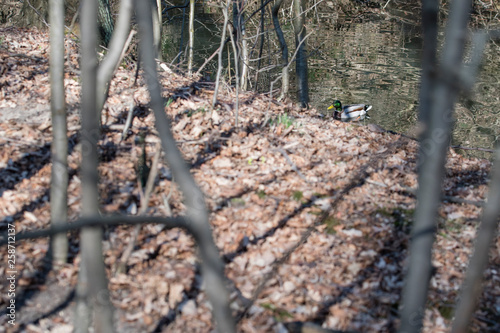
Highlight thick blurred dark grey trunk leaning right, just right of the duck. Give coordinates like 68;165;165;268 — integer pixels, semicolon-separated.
399;0;471;333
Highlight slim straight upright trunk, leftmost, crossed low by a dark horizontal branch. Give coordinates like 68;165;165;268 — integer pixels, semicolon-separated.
49;0;68;264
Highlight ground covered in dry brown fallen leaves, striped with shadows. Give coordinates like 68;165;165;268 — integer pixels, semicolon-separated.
0;28;500;333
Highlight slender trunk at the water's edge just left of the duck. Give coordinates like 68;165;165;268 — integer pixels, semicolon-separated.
293;0;309;107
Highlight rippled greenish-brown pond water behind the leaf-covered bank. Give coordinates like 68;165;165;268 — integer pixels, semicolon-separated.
163;7;500;158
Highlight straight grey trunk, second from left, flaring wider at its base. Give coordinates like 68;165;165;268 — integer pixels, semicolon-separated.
75;0;113;332
